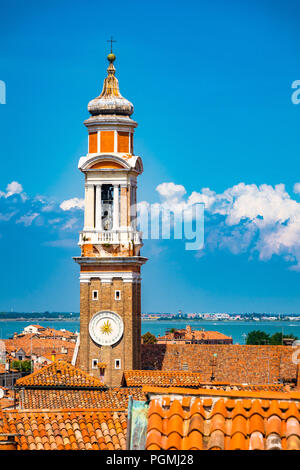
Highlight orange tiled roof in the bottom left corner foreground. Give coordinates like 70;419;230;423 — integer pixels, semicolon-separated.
0;409;127;450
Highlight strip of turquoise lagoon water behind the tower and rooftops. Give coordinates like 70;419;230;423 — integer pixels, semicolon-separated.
0;320;300;344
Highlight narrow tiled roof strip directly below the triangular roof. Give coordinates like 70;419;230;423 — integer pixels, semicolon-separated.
18;387;146;411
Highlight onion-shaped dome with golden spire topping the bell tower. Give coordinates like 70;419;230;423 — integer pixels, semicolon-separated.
88;52;133;116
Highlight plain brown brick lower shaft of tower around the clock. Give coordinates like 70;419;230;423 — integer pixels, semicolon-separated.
79;278;141;386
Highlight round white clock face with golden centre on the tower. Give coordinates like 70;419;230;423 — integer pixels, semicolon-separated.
89;312;124;346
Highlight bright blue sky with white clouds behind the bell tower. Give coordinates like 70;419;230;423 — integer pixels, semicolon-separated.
0;0;300;313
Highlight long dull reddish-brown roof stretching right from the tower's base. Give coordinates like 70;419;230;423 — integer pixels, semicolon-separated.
142;344;297;384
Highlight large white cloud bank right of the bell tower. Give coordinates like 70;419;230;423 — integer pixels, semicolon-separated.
147;183;300;271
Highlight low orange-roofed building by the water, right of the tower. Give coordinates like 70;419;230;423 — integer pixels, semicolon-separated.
157;325;233;344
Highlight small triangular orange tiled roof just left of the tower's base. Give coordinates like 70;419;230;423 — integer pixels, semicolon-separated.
16;359;104;388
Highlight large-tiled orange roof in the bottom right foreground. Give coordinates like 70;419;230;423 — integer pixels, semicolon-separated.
146;394;300;450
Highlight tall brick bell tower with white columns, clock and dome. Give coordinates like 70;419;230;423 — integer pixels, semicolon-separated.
74;48;147;386
